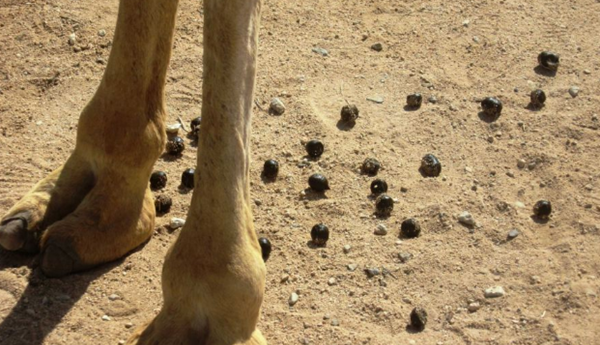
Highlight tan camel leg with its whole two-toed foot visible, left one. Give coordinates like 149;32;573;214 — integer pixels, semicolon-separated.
0;0;177;276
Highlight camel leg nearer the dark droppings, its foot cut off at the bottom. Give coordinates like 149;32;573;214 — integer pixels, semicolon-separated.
129;0;266;345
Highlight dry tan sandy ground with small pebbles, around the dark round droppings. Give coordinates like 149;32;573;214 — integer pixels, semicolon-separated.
0;0;600;345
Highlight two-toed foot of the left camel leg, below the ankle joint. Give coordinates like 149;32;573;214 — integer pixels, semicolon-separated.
0;148;155;277
